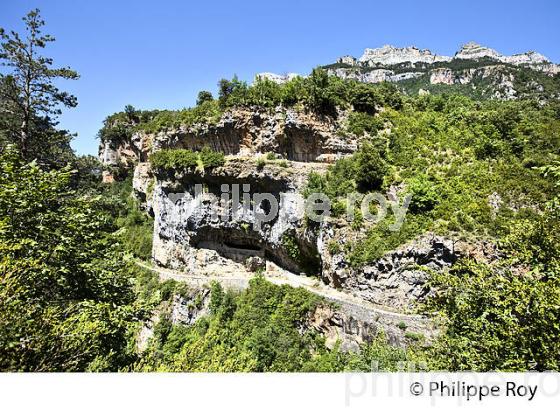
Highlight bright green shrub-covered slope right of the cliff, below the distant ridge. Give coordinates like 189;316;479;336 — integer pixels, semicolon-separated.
308;96;560;264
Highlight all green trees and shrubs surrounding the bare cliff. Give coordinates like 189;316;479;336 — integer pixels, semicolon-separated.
0;11;560;371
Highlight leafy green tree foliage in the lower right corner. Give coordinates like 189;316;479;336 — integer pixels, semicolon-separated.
426;168;560;371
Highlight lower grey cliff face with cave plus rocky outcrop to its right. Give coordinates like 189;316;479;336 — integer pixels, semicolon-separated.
144;157;462;311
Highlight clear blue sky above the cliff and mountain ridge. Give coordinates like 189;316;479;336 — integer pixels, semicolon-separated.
0;0;560;154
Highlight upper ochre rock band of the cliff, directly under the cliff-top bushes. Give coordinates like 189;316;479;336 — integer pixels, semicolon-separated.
99;107;357;175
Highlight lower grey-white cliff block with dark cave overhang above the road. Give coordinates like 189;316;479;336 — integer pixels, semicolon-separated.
152;157;320;274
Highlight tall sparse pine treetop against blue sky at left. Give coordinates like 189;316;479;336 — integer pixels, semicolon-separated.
0;9;78;163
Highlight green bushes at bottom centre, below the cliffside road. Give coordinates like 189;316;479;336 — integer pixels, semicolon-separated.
134;277;420;372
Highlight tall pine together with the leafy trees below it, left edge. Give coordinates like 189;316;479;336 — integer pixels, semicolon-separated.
0;10;150;371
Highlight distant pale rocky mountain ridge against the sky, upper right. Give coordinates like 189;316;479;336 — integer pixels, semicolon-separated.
255;41;560;103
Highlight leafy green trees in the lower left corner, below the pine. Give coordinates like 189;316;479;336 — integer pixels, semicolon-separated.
0;149;147;371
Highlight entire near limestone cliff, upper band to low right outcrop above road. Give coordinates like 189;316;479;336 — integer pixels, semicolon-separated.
100;103;460;320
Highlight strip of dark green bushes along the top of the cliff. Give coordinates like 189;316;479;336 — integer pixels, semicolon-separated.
99;69;403;141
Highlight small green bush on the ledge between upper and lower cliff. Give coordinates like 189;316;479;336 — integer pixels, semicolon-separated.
150;147;225;171
